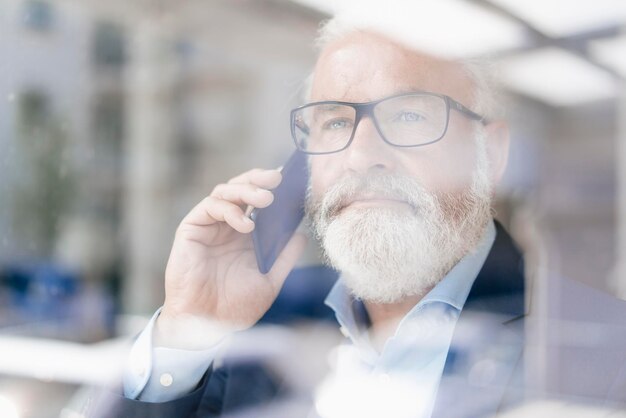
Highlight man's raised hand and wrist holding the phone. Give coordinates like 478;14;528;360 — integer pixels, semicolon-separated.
155;169;306;349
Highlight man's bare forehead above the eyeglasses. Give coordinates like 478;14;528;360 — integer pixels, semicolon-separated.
311;31;472;103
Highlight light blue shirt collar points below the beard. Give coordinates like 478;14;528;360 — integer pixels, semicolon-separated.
324;221;496;340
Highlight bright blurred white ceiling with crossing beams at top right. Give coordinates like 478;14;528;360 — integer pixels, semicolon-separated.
292;0;626;107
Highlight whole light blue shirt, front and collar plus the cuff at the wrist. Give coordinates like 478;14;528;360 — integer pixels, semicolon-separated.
124;222;496;417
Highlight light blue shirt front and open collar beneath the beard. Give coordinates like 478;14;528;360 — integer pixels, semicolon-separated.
325;222;495;417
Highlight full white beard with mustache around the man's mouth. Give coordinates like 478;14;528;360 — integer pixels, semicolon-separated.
306;137;491;303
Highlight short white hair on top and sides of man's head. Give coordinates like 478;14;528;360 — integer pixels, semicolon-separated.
303;18;505;120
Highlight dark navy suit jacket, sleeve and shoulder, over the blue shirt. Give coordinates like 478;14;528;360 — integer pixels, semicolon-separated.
87;223;626;418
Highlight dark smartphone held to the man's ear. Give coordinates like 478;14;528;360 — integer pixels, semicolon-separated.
250;151;309;274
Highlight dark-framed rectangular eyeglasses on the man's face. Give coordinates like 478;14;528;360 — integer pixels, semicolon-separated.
291;92;487;154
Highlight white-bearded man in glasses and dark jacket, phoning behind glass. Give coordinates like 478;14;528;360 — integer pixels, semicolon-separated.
91;15;624;417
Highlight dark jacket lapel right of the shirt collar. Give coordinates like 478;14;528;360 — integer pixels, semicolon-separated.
432;222;527;417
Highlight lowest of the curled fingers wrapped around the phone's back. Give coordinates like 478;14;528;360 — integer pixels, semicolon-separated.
182;196;254;233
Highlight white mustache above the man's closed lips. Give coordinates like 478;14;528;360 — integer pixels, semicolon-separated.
307;174;436;219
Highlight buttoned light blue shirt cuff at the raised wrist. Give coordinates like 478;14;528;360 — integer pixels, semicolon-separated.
123;308;222;402
